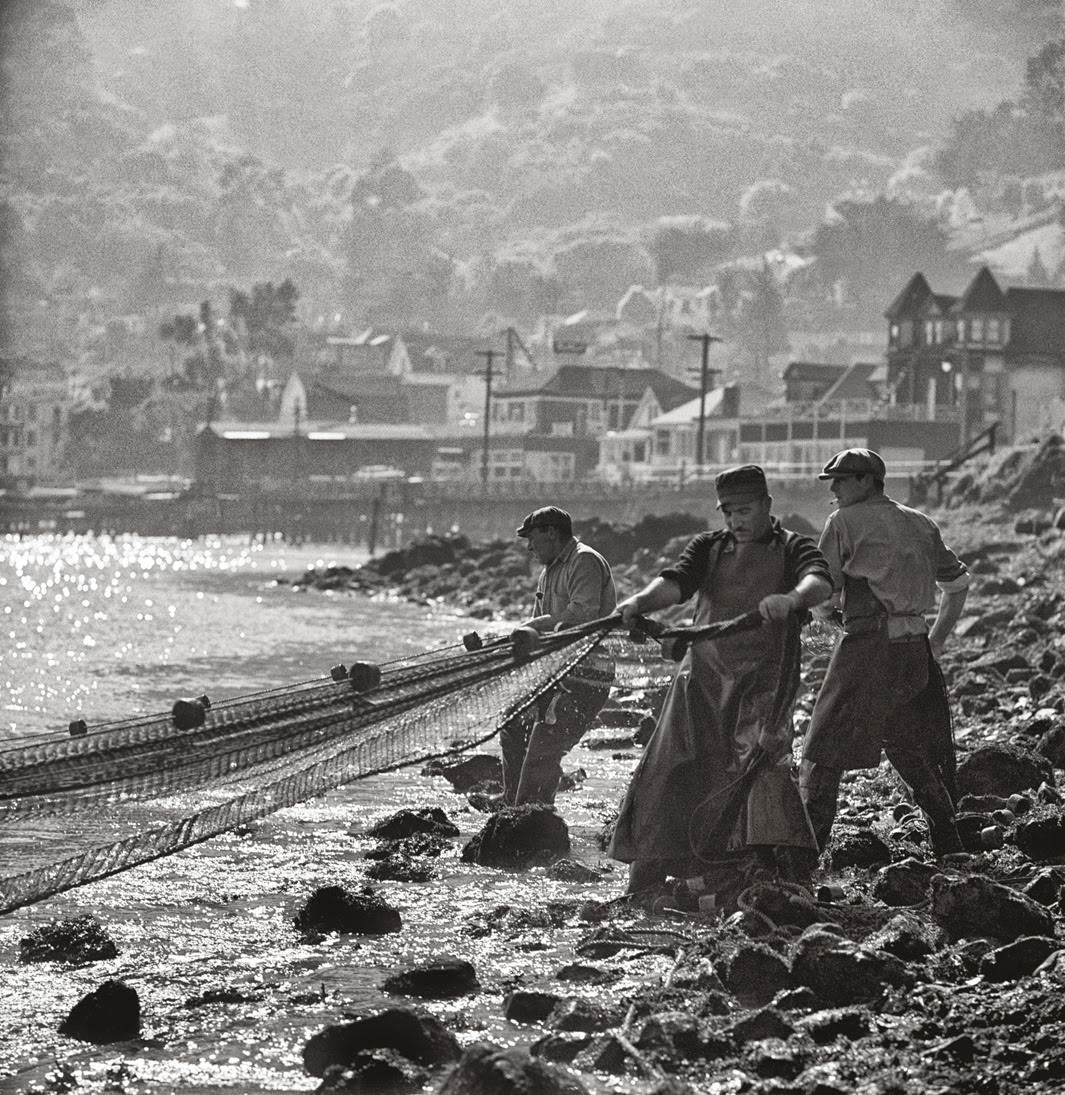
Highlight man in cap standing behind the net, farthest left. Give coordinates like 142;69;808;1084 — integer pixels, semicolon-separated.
499;506;617;806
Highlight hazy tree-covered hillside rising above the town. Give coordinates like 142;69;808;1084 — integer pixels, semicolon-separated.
0;0;1065;344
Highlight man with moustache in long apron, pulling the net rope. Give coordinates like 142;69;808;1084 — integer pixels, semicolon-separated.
609;464;832;894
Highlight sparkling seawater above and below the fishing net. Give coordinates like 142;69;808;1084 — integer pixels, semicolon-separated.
0;537;632;1093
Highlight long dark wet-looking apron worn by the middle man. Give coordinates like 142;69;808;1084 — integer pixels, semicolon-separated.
610;539;817;864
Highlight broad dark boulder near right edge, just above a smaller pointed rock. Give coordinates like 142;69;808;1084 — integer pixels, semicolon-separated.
929;875;1054;943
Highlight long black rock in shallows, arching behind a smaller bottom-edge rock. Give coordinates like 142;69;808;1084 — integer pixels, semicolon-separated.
303;1007;462;1076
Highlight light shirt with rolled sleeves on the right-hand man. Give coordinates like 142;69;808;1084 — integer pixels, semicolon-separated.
819;494;969;638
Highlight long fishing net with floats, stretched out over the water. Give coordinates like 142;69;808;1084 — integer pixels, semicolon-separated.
0;620;616;912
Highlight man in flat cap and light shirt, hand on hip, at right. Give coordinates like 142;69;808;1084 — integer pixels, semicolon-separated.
800;449;969;855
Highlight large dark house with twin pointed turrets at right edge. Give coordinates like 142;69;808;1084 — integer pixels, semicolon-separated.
884;266;1065;441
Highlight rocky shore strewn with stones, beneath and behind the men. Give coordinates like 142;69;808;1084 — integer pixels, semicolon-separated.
278;437;1065;1095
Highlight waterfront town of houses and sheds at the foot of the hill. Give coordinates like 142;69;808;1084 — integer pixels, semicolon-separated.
0;267;1065;540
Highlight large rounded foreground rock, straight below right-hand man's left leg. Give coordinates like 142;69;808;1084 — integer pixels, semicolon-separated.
791;924;913;1005
